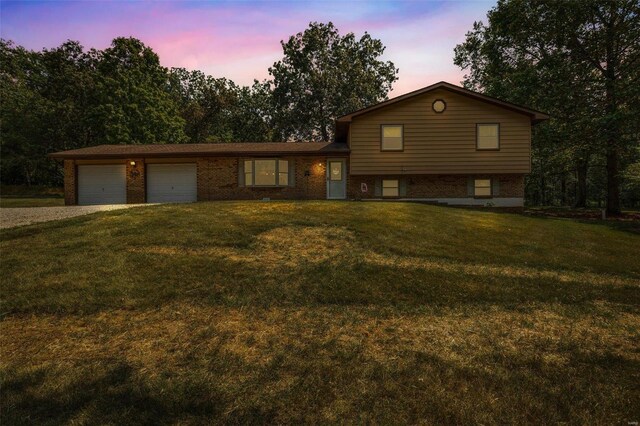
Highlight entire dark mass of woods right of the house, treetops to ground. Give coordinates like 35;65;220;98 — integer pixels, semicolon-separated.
454;0;640;214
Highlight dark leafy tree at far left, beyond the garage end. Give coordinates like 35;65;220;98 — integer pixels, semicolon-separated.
0;41;93;184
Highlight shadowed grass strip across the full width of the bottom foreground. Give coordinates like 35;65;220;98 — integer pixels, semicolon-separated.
2;339;640;424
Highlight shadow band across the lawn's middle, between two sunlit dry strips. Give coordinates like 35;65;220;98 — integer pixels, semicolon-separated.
2;256;640;316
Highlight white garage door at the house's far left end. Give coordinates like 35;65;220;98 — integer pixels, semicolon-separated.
78;164;127;205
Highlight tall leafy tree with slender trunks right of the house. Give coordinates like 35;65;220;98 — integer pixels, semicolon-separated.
455;0;640;214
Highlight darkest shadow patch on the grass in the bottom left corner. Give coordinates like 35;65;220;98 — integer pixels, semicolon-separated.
2;360;229;424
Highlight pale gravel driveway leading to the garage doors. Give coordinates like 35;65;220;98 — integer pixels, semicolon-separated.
0;204;151;229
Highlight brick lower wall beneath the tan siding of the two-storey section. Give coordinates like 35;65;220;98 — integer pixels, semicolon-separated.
348;174;524;199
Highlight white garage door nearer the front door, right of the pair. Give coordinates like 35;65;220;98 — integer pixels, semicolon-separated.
147;163;198;203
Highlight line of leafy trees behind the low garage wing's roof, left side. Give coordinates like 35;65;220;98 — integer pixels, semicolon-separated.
0;22;398;185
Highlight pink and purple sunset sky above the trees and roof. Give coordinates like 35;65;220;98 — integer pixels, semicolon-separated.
0;1;495;95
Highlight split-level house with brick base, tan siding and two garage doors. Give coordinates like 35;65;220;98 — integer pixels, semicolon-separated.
51;82;549;207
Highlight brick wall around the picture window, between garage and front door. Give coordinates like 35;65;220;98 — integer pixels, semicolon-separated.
197;157;327;201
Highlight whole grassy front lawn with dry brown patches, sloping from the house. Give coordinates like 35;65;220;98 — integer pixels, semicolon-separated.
0;202;640;425
